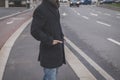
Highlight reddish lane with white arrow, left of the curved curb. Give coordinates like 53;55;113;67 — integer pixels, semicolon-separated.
0;10;33;49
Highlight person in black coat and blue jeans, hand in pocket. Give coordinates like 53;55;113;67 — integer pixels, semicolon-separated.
31;0;66;80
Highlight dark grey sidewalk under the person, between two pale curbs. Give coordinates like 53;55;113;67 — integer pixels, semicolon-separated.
3;25;79;80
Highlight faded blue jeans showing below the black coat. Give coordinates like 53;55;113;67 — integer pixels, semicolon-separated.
43;68;58;80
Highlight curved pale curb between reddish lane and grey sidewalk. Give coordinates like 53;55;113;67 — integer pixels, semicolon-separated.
0;19;32;80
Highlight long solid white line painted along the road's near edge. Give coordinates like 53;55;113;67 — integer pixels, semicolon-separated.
65;37;115;80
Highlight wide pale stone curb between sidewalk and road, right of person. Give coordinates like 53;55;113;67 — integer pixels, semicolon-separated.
65;46;97;80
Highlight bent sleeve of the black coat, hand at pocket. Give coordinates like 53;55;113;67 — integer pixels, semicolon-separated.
31;9;53;46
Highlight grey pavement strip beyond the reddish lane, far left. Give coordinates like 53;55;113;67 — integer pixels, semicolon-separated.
0;7;27;18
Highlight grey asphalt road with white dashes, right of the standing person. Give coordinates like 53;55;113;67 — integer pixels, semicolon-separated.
60;4;120;80
